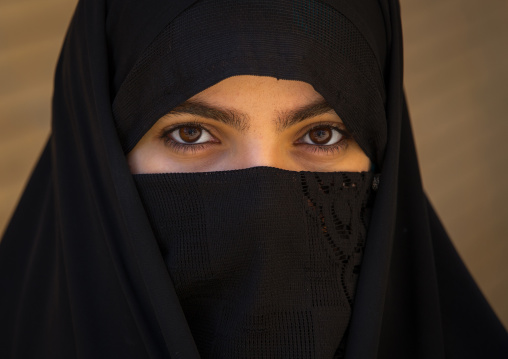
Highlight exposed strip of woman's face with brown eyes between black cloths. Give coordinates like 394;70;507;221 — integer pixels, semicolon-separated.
127;76;370;174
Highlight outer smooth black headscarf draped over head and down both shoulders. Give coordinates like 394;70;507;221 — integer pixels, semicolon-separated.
0;0;508;358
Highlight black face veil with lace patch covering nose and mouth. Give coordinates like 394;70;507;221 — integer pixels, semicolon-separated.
134;167;374;358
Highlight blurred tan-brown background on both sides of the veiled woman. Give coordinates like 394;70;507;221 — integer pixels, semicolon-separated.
0;0;508;327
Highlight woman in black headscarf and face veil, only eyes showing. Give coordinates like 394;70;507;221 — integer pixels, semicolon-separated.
0;0;508;358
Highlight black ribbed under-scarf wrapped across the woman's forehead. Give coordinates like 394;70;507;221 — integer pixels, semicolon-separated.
113;0;386;164
